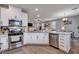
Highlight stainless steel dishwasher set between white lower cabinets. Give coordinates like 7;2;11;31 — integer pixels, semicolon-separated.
49;33;59;48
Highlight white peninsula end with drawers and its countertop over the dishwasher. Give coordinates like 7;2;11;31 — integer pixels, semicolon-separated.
50;31;72;53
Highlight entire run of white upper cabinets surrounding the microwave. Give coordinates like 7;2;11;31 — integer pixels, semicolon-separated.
0;6;28;26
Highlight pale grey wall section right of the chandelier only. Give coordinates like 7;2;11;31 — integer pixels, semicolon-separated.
69;15;79;37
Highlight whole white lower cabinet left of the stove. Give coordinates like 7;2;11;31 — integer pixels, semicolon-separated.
0;35;9;51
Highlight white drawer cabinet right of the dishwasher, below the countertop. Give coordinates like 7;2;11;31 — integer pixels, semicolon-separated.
59;34;71;53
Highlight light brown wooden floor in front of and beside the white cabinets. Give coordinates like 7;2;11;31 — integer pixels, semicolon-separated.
3;40;79;54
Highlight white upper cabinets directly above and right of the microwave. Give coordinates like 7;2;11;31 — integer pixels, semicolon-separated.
9;6;28;26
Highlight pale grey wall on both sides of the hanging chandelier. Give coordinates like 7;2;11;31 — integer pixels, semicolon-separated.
57;15;79;37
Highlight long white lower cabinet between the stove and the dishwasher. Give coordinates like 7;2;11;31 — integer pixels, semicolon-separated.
24;33;49;44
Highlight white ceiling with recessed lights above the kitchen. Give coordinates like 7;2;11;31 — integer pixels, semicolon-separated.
10;4;79;21
